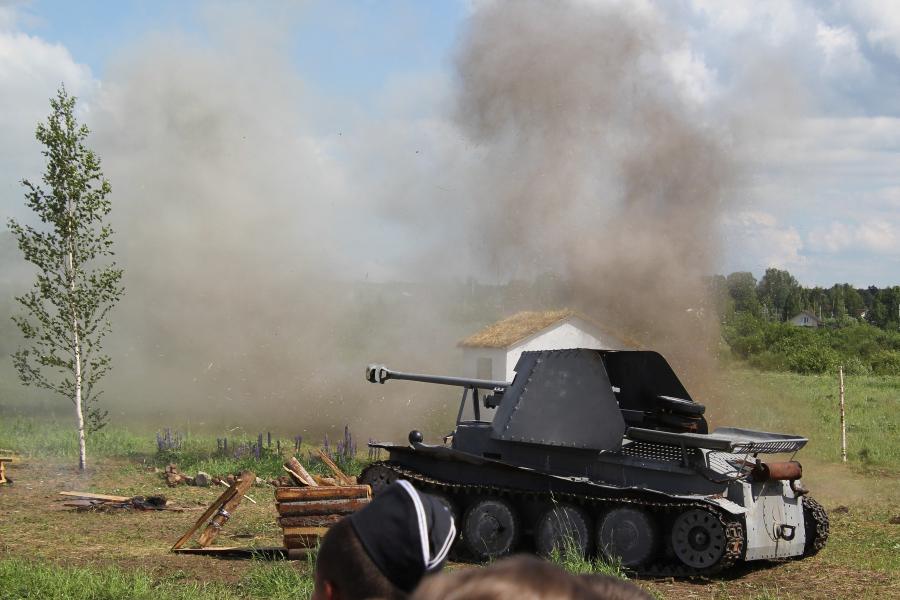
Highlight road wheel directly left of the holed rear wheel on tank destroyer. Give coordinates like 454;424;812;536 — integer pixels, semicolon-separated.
597;507;657;568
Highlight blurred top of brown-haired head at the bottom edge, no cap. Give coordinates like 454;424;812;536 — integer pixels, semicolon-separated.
412;555;649;600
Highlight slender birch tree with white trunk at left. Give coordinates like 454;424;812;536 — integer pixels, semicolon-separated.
9;86;124;471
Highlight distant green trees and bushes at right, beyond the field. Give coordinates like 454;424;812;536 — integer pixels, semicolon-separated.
711;269;900;375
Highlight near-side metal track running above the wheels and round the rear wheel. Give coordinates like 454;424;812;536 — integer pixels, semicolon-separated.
359;461;744;577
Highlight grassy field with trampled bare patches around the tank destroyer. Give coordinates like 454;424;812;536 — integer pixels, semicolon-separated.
0;368;900;600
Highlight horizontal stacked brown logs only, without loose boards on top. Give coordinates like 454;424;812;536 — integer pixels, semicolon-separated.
275;485;372;549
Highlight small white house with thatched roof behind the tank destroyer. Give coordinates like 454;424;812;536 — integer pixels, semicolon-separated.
459;310;625;381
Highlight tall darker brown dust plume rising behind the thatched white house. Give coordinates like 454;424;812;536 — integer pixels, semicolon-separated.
456;1;735;388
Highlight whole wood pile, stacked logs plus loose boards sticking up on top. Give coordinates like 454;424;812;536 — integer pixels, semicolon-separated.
275;450;372;550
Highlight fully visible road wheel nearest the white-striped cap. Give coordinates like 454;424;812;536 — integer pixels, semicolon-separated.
462;498;520;561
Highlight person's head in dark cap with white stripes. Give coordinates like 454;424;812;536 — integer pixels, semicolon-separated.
313;481;456;600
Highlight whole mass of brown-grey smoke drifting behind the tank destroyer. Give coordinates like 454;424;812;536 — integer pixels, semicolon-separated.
3;1;760;437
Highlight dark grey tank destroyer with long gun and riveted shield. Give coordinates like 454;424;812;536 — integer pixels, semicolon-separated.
360;349;828;576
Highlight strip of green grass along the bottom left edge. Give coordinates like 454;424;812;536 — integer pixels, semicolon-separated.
0;558;313;600
